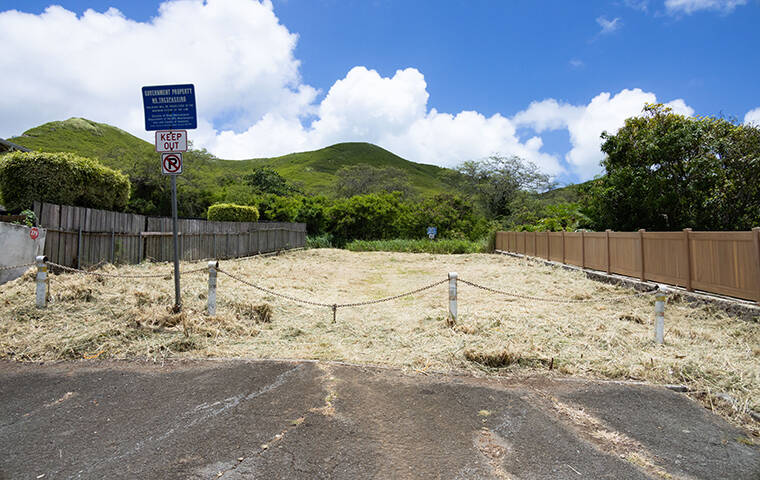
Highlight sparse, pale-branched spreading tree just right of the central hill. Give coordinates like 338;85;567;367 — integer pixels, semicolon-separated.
457;155;554;219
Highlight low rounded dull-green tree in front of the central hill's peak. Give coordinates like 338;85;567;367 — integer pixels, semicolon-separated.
335;164;412;197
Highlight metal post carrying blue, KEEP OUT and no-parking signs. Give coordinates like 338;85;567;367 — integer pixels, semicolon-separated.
142;84;198;312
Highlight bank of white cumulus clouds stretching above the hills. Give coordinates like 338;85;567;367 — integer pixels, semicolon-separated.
0;0;700;180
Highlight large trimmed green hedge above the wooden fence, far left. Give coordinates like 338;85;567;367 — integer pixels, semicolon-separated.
0;152;130;211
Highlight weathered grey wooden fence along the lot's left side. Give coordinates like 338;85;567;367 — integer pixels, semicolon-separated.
34;202;306;268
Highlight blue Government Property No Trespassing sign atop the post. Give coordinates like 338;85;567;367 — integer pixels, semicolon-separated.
143;83;198;130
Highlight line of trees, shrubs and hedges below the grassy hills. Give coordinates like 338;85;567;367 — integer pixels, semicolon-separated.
0;104;760;238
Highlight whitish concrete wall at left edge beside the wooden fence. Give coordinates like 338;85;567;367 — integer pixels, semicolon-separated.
0;222;45;285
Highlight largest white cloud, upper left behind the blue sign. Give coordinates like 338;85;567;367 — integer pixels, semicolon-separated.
0;0;317;138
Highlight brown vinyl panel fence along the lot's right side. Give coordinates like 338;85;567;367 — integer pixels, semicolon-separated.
496;228;760;303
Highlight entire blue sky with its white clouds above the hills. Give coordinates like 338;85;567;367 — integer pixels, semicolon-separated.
0;0;760;182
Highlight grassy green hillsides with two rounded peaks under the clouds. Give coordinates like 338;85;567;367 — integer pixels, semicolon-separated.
8;118;458;194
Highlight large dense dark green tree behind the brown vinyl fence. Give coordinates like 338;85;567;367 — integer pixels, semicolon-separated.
582;104;760;230
